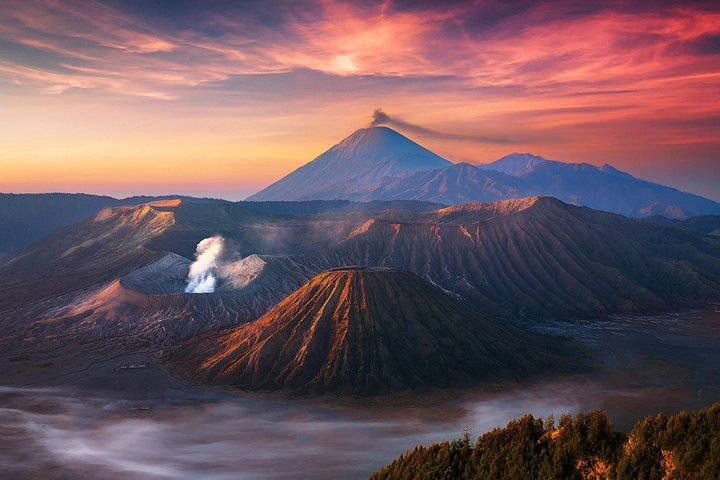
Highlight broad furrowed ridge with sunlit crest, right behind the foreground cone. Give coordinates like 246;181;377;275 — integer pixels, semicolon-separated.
278;197;720;318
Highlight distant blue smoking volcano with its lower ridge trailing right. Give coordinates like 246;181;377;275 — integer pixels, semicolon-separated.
247;127;720;218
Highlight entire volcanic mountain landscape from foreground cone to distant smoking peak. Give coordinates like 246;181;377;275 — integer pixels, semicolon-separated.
0;128;720;394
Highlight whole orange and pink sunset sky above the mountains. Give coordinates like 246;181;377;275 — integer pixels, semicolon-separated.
0;0;720;200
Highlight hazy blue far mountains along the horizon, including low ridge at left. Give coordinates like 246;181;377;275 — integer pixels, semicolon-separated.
0;127;720;256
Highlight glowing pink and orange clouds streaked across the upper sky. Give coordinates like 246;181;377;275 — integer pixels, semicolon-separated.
0;0;720;171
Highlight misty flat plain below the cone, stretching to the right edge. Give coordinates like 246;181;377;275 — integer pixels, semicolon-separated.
0;311;720;480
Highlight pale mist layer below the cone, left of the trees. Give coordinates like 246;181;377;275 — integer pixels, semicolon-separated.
0;387;578;479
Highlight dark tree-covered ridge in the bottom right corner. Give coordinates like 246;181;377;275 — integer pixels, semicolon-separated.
370;403;720;480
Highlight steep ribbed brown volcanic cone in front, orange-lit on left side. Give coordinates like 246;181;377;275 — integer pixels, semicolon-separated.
166;268;562;394
